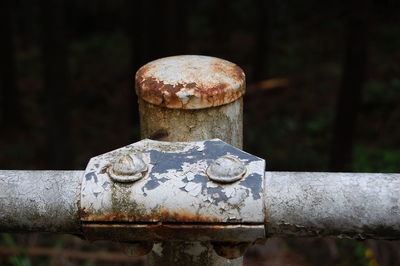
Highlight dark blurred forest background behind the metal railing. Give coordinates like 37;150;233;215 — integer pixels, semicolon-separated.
0;0;400;266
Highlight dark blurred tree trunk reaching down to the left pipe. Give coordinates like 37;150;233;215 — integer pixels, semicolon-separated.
40;0;73;169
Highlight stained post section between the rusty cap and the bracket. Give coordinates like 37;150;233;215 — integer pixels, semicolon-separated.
139;98;243;148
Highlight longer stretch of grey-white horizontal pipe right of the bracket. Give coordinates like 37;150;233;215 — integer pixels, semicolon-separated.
265;172;400;239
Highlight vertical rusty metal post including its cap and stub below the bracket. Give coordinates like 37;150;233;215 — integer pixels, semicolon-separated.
135;55;245;265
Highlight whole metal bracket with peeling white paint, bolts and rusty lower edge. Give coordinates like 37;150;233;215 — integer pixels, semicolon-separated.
80;139;265;242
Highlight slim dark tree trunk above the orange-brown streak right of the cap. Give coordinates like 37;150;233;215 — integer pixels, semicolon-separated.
253;0;270;81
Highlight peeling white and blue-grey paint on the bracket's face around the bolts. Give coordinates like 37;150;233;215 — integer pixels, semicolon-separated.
81;140;265;224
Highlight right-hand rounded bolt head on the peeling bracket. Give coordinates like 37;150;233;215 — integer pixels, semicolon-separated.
206;155;246;183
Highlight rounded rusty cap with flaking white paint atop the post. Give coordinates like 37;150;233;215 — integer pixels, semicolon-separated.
135;55;245;109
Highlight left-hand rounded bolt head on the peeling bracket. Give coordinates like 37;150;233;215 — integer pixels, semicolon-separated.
107;154;147;183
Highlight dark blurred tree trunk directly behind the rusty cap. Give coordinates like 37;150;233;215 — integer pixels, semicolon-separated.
127;0;187;140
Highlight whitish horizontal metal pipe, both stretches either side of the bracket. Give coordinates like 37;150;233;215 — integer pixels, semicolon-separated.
0;170;400;239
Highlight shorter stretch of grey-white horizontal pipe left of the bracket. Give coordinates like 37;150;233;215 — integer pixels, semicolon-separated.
0;170;84;234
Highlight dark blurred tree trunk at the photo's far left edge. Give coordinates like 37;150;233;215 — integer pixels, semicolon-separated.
0;0;22;129
